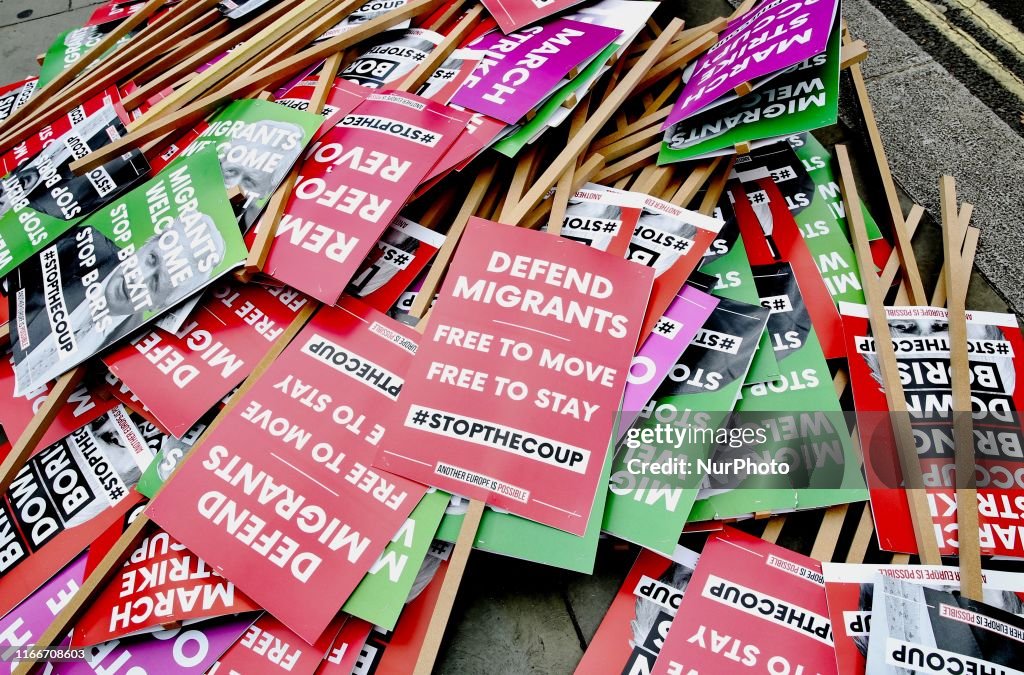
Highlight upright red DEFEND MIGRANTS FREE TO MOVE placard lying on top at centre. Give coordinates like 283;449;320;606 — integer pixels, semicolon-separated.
378;218;653;536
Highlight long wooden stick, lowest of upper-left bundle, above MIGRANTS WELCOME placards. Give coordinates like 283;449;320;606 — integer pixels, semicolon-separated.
71;0;440;173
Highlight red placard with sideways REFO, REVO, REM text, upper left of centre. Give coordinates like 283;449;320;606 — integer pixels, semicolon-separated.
264;92;468;304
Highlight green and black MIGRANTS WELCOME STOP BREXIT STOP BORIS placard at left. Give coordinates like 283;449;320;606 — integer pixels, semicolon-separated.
8;153;246;394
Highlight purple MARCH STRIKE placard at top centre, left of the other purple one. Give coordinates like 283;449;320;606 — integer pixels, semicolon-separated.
452;18;622;124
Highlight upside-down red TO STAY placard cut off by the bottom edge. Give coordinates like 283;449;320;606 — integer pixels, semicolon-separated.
652;528;837;675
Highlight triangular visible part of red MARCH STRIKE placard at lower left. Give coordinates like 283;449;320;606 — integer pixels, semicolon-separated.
72;531;259;646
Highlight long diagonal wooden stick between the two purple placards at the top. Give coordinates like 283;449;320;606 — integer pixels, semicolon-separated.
499;18;683;222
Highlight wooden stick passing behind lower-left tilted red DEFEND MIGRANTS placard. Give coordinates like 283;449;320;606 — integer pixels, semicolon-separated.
13;301;319;675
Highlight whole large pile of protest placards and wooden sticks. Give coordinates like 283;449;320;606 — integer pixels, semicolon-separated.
0;0;1024;675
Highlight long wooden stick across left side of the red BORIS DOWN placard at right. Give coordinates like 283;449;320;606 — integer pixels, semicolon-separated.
836;145;941;564
